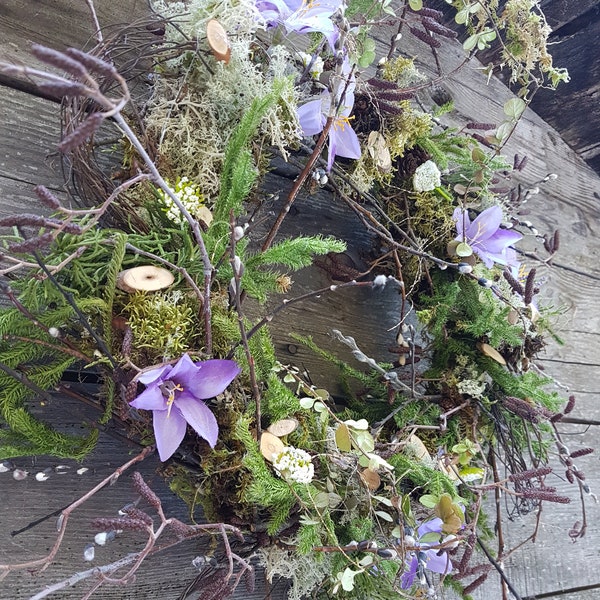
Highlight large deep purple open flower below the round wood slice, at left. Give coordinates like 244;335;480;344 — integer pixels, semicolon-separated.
131;354;240;461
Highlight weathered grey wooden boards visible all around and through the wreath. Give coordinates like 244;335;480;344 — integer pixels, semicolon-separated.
0;0;600;600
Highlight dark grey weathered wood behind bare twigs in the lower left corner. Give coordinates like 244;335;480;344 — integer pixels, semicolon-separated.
0;395;274;600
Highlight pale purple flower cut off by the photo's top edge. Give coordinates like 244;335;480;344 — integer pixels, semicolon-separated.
256;0;343;50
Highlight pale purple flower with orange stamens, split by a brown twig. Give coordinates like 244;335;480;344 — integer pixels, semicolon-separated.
298;58;361;171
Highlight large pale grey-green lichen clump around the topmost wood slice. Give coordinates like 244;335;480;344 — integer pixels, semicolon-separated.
147;1;300;201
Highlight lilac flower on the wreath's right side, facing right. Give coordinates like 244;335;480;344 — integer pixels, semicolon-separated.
453;206;523;269
